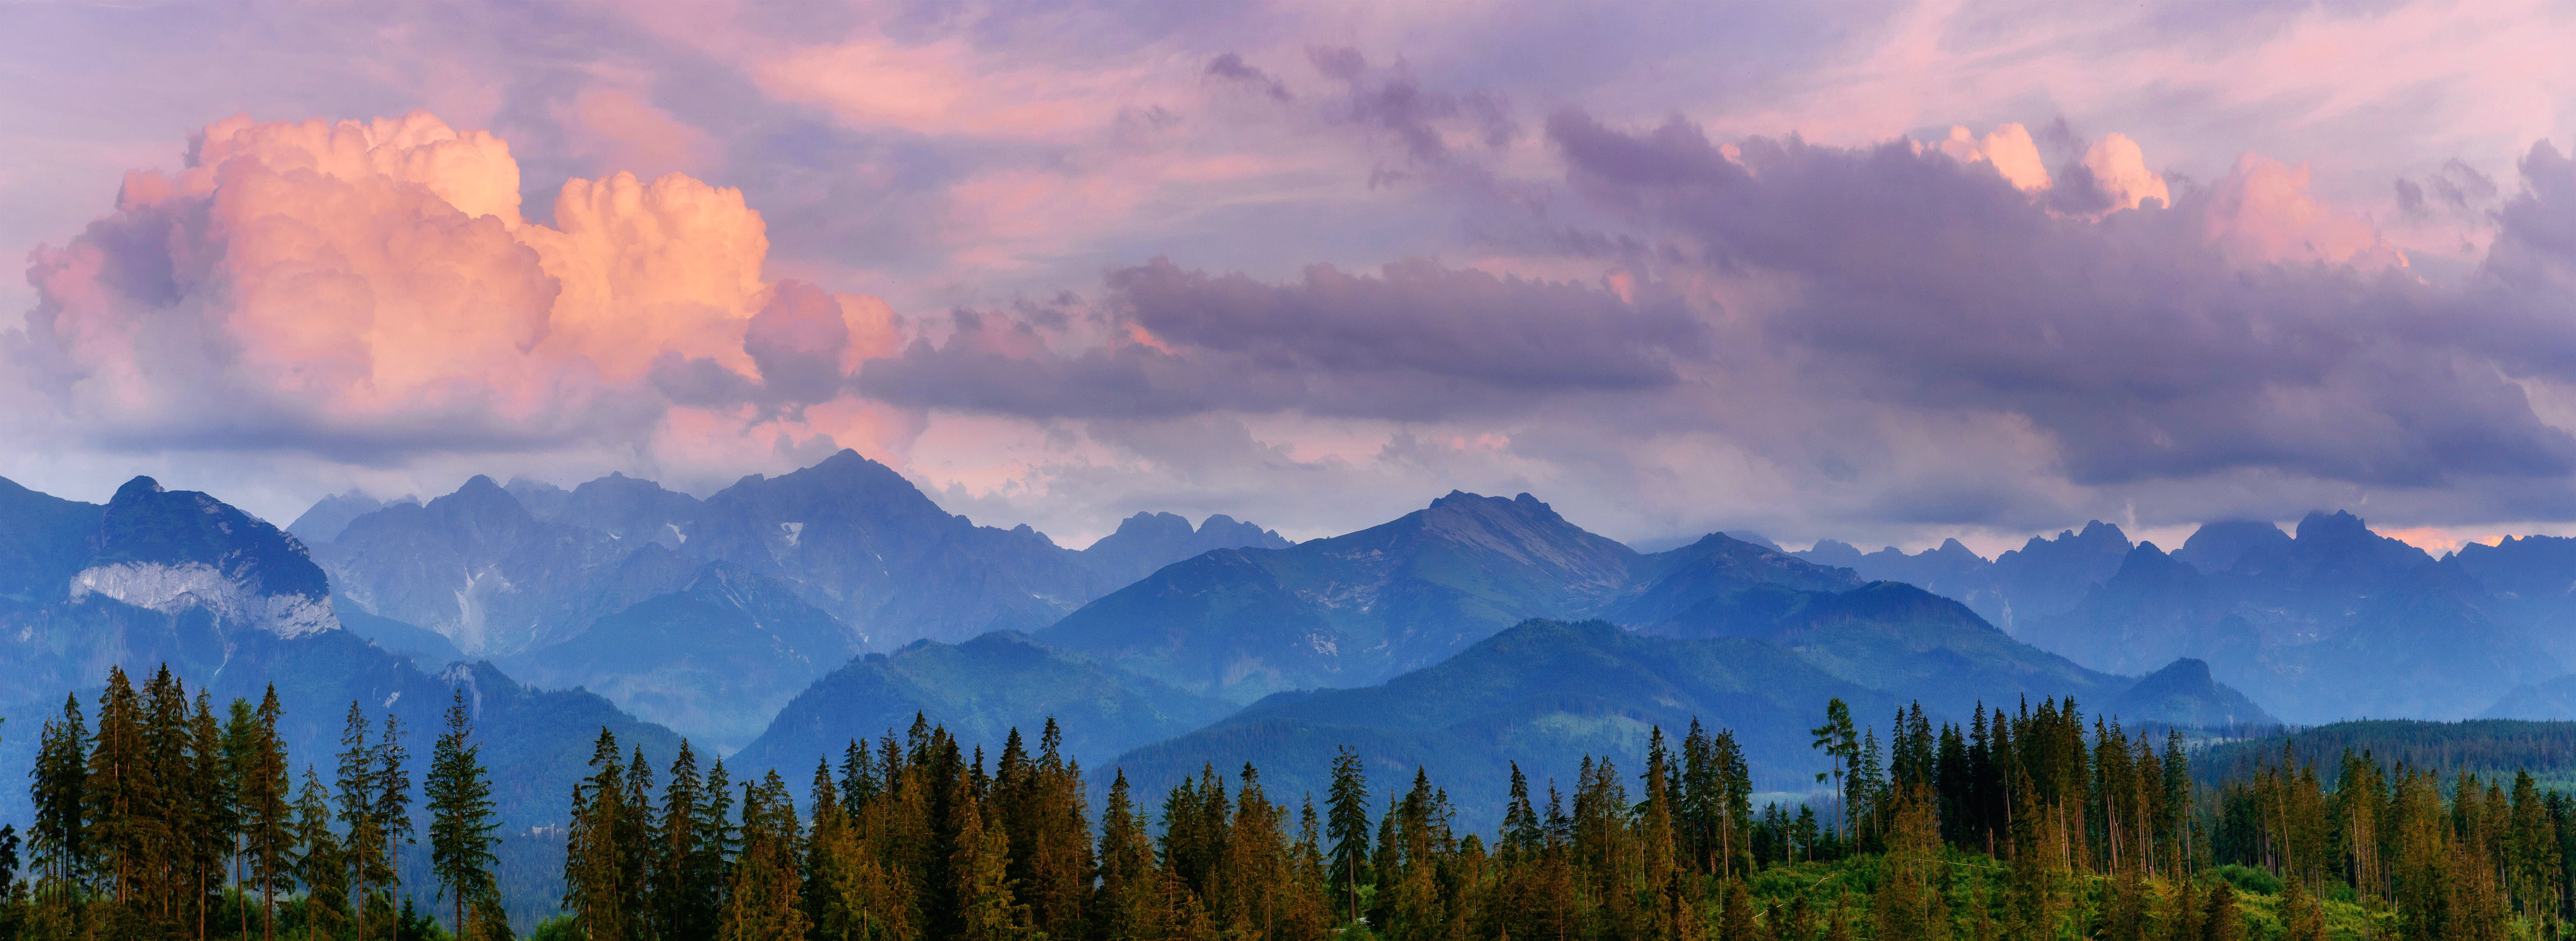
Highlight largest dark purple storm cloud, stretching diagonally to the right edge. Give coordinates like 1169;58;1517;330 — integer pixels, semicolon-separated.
1548;111;2576;487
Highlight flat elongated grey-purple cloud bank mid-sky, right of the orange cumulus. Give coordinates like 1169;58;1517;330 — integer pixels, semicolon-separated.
858;258;1710;420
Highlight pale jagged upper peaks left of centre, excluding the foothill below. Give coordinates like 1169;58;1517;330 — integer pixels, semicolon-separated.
314;451;1285;657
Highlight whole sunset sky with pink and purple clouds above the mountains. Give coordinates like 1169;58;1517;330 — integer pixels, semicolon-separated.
0;0;2576;554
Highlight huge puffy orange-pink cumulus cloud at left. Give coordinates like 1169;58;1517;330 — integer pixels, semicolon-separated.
0;111;896;464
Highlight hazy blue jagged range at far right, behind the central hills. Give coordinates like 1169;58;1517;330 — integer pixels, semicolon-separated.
1803;513;2576;725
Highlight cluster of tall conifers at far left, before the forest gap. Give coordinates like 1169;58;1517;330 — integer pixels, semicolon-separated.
0;668;507;941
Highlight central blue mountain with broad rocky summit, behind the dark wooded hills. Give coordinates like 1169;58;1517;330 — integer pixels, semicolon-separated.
1038;492;2267;719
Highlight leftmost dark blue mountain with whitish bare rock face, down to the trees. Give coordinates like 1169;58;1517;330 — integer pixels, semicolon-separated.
0;477;677;828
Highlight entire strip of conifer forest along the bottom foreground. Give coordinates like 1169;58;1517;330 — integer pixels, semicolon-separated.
15;668;2576;941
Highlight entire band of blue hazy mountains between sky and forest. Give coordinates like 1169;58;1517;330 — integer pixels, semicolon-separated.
0;451;2576;845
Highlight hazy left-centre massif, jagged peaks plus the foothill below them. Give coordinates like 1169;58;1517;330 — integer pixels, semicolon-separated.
307;451;1288;750
